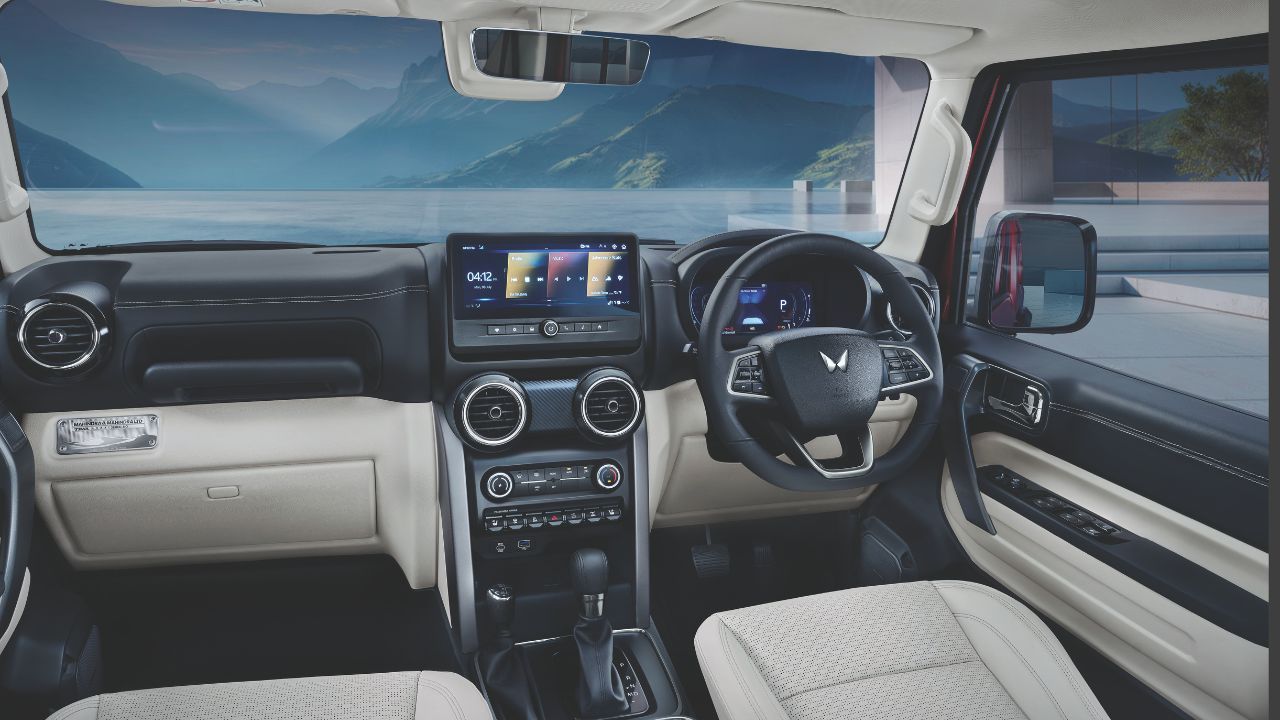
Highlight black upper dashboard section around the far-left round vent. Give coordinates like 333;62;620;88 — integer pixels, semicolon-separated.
0;249;431;411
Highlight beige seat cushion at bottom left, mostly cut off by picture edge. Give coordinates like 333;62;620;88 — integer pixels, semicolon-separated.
50;673;493;720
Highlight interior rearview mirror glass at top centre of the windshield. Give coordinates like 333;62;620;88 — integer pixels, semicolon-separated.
471;28;649;85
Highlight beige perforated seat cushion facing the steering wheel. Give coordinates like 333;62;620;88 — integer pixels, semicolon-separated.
694;582;1106;720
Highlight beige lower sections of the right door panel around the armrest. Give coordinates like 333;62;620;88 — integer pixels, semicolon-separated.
942;450;1268;720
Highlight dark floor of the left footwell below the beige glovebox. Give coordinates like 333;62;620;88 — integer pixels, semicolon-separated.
72;556;460;692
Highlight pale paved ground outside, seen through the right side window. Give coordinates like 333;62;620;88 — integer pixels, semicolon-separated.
1020;296;1268;416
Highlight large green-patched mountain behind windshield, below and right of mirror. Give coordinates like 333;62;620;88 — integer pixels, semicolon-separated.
384;85;872;188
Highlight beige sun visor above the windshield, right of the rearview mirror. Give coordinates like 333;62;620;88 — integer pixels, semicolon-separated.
667;3;973;56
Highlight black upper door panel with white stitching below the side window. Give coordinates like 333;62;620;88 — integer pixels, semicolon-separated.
943;325;1270;551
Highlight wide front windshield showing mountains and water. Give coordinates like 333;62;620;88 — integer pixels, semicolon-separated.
0;0;928;251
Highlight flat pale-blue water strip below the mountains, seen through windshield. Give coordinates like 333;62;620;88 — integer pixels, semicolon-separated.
31;190;882;250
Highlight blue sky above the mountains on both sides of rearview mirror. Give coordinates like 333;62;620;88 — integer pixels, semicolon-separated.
32;0;872;104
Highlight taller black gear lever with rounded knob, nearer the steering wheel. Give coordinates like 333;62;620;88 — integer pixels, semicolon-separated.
572;548;628;719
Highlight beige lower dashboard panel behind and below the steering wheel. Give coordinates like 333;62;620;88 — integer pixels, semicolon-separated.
645;380;915;528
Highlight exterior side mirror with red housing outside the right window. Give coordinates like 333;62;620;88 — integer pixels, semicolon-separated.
977;211;1098;333
